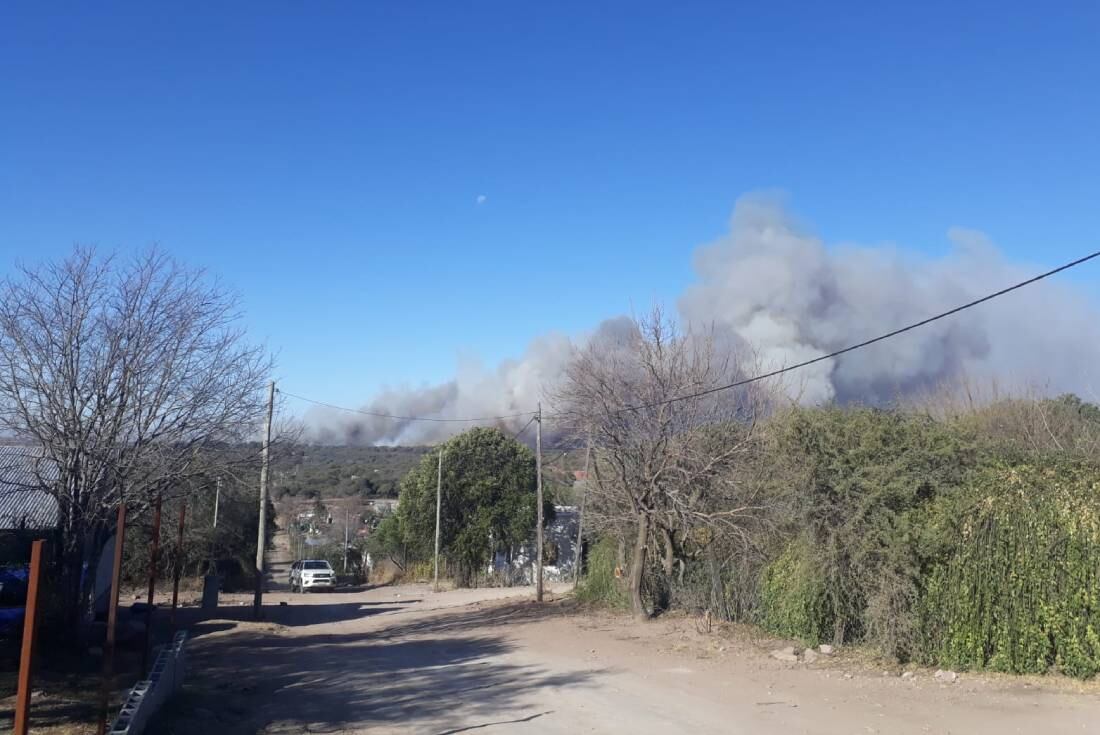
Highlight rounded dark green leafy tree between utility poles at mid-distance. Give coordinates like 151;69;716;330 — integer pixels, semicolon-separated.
397;428;553;585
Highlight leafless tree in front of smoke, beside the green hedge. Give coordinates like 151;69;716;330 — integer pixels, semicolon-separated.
557;309;772;617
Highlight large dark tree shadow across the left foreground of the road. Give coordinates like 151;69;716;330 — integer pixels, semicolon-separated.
151;605;597;735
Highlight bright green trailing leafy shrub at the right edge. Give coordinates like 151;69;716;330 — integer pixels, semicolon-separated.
922;462;1100;678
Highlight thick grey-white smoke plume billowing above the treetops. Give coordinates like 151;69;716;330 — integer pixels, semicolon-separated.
306;196;1100;445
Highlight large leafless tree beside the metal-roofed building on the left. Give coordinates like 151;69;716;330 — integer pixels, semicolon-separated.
0;248;272;629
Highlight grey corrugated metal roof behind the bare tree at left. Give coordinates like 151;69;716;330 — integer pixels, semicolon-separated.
0;446;57;530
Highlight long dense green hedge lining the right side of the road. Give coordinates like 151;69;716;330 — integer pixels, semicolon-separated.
580;396;1100;678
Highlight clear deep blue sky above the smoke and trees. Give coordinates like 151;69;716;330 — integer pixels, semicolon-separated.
0;2;1100;404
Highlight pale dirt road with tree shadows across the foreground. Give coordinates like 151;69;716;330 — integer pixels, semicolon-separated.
154;586;1100;735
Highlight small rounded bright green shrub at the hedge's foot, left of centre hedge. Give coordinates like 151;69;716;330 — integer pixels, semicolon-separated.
760;542;833;646
